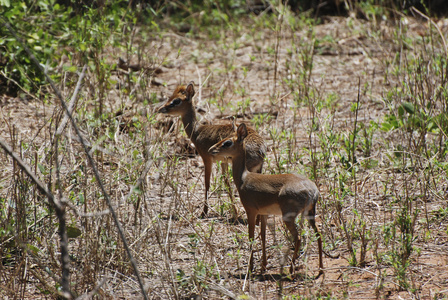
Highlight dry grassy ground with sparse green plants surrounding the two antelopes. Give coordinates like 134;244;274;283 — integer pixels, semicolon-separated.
0;0;448;299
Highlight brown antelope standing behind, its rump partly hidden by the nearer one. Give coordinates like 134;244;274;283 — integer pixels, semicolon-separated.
158;82;266;217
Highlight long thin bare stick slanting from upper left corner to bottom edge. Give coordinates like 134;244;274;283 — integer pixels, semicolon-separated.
2;18;148;299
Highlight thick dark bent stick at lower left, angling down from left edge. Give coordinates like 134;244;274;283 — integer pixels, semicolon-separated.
0;139;73;299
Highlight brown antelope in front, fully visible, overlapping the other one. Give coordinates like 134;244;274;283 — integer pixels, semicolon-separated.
209;124;323;278
